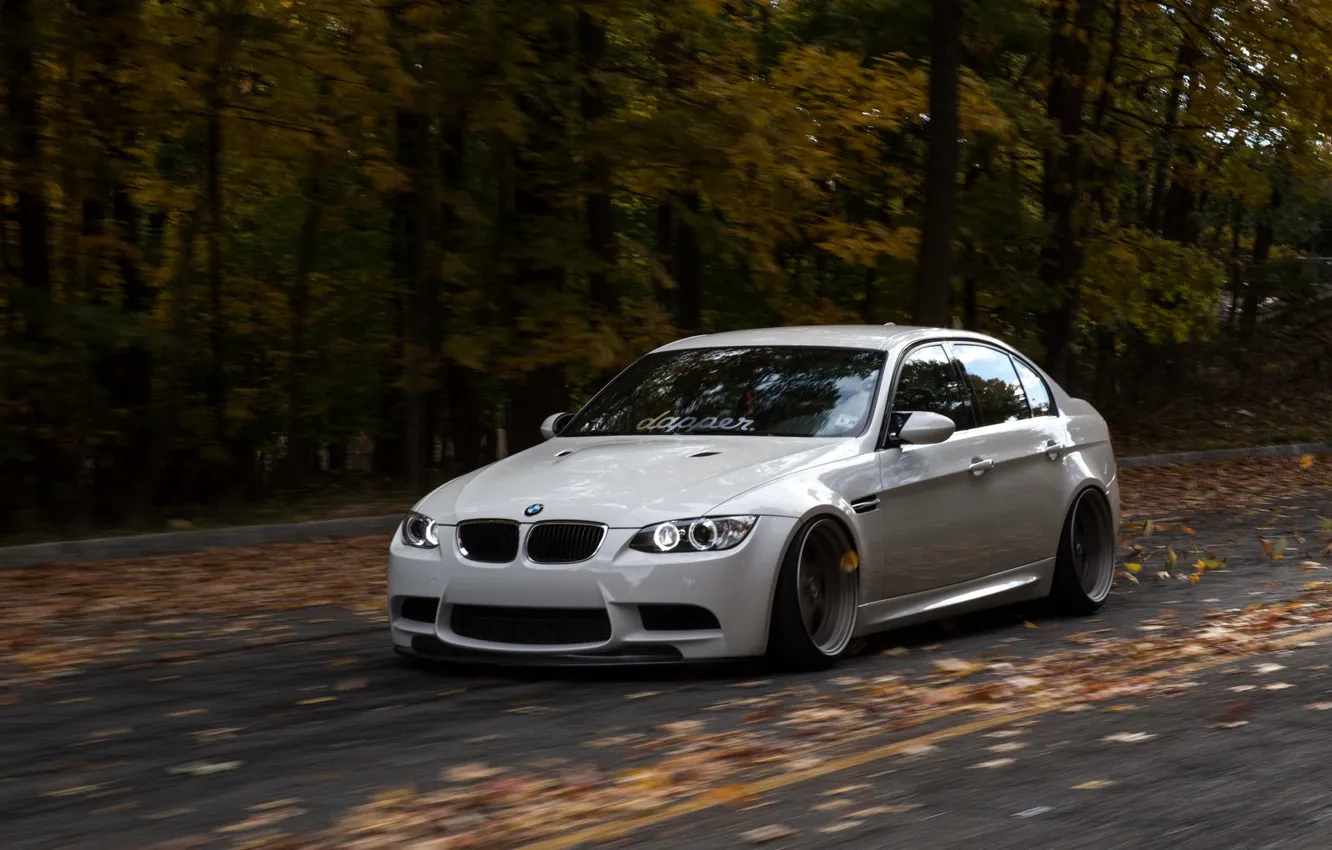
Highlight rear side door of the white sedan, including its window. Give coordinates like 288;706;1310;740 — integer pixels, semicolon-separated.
950;341;1064;578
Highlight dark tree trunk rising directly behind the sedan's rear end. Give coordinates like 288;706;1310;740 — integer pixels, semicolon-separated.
1040;0;1102;384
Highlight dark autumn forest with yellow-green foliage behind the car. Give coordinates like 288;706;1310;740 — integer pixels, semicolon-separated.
0;0;1332;536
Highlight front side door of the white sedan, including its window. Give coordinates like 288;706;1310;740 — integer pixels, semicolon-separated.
876;342;996;598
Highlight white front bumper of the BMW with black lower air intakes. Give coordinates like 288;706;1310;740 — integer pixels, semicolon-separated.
389;517;797;665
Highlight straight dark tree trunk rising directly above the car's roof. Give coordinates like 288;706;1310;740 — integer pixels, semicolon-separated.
911;0;962;328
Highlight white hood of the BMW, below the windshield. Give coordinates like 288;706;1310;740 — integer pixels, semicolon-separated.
416;437;858;529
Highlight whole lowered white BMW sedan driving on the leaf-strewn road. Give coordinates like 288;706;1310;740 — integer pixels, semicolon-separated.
388;325;1119;669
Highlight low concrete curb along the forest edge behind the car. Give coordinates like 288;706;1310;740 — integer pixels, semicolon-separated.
0;442;1332;570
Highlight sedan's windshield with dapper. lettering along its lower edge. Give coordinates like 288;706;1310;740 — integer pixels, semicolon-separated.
559;346;884;437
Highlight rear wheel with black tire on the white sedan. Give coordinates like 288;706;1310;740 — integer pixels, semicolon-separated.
1047;488;1115;617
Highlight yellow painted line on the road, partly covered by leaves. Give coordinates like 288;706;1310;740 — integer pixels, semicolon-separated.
521;625;1332;850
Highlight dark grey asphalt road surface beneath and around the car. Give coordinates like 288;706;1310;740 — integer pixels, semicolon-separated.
0;489;1332;850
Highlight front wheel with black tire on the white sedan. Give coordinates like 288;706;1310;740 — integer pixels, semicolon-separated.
767;517;860;671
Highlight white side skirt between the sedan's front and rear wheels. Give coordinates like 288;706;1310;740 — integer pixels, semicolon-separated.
855;558;1055;637
